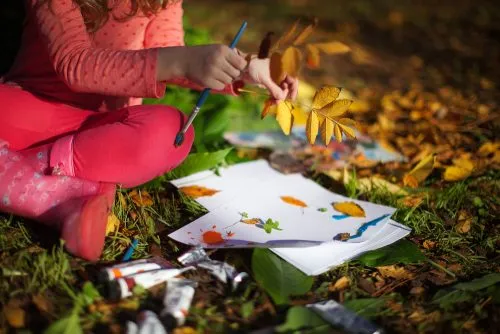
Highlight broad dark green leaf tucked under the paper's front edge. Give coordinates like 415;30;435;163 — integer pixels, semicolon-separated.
252;248;313;304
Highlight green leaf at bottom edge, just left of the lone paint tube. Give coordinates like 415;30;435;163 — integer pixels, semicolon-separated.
276;306;331;333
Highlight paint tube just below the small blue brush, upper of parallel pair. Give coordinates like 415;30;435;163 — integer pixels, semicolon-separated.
98;256;174;283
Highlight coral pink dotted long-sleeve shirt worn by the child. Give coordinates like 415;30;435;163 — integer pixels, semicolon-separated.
3;0;235;111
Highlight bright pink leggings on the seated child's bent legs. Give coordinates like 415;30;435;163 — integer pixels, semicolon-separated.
0;84;194;187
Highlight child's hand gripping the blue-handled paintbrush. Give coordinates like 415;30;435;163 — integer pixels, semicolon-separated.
183;44;247;90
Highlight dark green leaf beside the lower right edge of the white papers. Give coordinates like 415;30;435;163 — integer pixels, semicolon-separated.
356;240;427;267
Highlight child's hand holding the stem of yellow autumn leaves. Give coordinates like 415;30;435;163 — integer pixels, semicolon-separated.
243;58;299;102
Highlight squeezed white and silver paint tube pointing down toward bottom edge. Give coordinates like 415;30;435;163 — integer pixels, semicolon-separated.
160;279;197;330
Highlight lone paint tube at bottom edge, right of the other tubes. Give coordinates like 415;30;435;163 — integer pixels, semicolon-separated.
306;300;384;334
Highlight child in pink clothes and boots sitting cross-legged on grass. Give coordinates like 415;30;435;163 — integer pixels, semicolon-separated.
0;0;298;261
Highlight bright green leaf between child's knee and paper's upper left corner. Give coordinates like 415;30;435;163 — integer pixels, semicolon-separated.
170;147;232;178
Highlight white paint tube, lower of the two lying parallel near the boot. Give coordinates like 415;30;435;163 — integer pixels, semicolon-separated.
108;267;195;300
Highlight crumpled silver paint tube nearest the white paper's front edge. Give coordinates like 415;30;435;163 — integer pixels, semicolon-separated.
177;246;249;291
